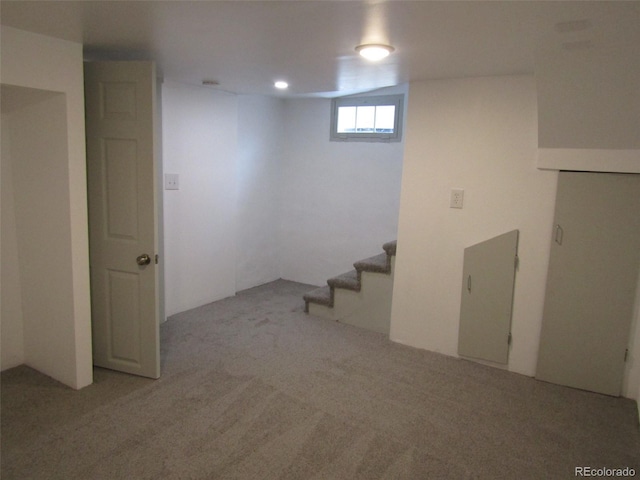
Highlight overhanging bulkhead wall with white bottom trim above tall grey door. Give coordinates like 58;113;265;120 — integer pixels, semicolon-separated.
535;2;640;173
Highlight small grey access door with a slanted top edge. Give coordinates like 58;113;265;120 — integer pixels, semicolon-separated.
458;230;518;364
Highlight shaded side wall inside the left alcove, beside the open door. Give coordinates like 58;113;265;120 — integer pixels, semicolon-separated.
4;94;76;384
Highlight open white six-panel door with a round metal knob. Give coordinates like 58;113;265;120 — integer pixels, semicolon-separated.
85;62;160;378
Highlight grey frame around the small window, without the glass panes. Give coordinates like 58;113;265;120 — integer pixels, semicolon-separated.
329;94;404;142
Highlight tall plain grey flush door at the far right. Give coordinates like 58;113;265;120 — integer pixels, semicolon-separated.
536;172;640;396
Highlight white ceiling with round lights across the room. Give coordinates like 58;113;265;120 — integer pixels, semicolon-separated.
0;0;640;96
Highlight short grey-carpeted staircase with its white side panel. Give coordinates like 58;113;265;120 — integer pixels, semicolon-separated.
303;240;397;334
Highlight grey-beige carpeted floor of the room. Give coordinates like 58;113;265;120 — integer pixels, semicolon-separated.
1;280;640;480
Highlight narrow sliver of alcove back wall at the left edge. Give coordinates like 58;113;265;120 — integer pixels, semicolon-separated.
0;113;24;370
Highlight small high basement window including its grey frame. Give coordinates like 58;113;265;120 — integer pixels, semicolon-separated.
330;95;403;142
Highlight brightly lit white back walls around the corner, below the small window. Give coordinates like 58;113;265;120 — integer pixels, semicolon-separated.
162;85;407;308
